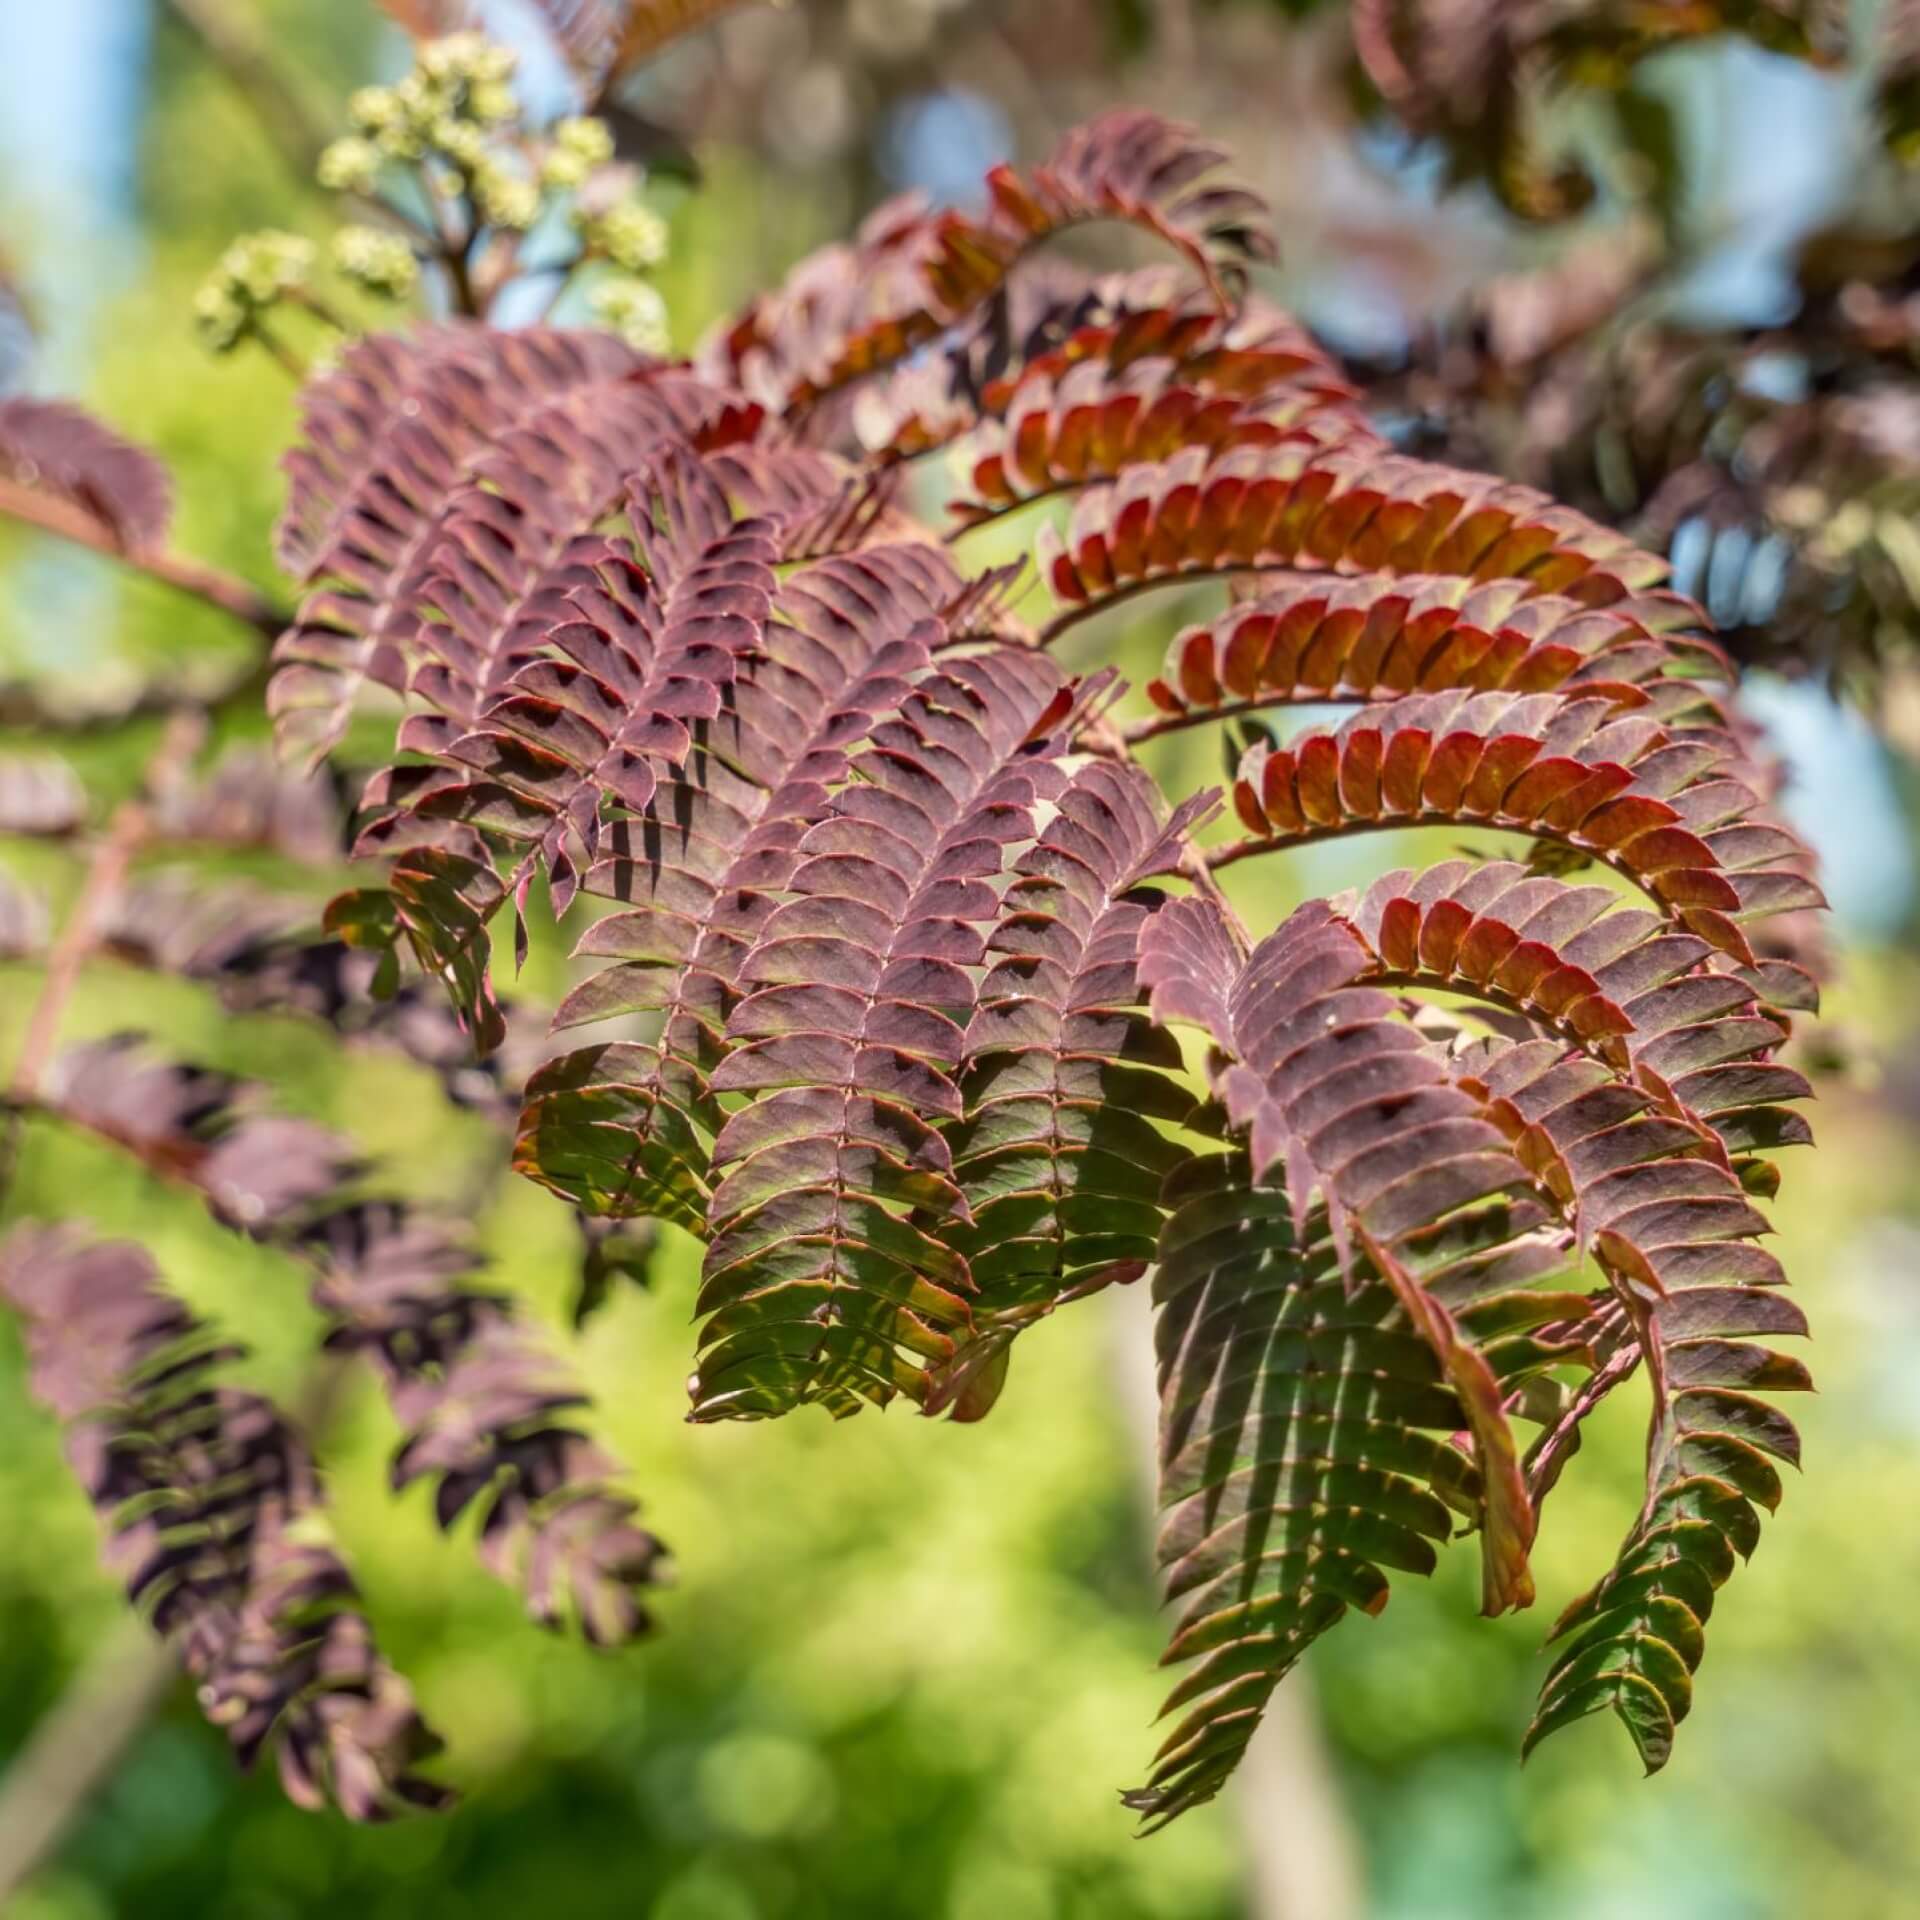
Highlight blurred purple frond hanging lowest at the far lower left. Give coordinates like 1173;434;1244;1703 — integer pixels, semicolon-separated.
0;1227;451;1820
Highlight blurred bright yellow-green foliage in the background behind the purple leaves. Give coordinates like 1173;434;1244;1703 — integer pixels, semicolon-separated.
0;0;1920;1920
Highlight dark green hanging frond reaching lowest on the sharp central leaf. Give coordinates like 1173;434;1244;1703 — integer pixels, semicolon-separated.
1125;1154;1482;1826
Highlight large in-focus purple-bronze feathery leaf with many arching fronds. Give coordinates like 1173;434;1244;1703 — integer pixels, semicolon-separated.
259;112;1822;1824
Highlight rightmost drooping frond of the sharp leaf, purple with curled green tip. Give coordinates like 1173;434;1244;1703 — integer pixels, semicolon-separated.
1467;1036;1811;1772
